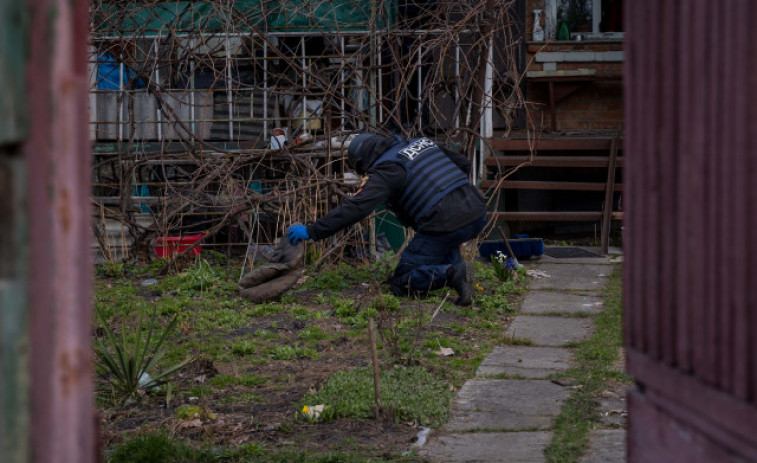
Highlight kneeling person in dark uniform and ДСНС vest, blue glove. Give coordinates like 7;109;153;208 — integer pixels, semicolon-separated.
288;133;486;305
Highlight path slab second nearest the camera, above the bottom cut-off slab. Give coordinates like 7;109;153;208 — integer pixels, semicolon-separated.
445;379;570;432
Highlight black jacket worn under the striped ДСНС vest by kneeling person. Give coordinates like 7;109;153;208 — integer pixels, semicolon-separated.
307;136;486;240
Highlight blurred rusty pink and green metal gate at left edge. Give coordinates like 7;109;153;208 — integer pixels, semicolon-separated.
0;0;98;463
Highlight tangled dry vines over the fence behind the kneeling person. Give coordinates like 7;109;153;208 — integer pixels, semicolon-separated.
90;0;527;266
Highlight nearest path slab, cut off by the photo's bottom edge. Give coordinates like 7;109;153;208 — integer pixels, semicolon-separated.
419;431;552;463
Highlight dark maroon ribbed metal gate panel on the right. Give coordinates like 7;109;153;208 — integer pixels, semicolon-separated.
624;0;757;462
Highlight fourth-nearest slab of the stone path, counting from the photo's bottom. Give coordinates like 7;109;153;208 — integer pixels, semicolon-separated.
505;316;594;347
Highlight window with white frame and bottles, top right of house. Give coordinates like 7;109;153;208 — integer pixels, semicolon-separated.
546;0;623;40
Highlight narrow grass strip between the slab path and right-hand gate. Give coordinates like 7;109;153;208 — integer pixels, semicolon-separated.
544;268;629;463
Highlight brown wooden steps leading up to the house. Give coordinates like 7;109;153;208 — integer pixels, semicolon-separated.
480;137;623;254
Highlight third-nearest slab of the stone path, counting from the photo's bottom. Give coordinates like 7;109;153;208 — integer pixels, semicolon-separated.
476;346;573;379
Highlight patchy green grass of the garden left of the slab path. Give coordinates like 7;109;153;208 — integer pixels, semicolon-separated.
95;257;523;462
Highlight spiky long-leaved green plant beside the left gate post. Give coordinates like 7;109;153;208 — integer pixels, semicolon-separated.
95;305;192;398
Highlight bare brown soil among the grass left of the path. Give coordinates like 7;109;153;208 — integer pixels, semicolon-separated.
101;260;522;457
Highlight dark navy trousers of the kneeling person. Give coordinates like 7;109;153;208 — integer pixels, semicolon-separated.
390;216;486;294
